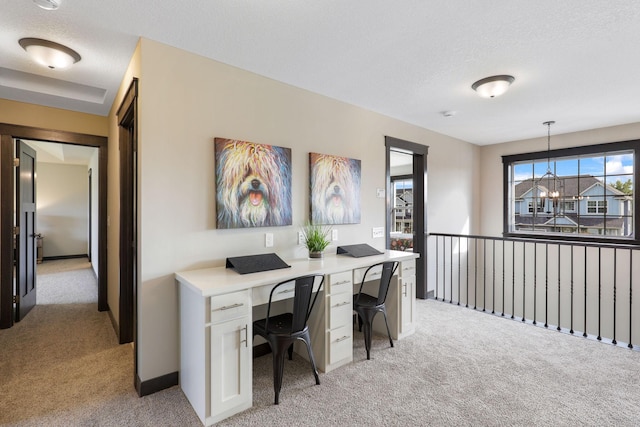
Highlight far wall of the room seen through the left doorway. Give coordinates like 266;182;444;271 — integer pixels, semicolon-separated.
36;162;89;257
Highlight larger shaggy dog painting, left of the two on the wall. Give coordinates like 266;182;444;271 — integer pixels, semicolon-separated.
215;138;291;228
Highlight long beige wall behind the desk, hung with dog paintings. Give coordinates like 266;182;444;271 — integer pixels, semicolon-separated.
130;39;479;381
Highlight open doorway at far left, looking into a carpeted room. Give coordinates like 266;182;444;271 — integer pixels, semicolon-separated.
22;140;99;305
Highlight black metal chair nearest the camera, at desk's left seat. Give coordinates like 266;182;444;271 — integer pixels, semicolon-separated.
253;275;324;405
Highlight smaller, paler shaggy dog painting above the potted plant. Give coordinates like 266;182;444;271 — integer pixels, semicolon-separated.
309;153;360;224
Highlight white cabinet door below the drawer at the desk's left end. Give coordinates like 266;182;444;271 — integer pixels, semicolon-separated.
211;317;253;418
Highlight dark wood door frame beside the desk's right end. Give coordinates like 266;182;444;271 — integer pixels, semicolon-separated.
384;136;429;299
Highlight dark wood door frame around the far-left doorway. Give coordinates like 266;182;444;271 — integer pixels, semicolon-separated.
0;123;109;329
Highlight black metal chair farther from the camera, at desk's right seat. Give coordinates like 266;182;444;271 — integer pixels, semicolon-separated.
353;261;398;360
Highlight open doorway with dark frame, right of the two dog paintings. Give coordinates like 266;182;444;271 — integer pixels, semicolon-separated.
385;136;429;299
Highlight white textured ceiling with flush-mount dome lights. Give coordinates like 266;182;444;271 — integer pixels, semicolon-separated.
0;0;640;145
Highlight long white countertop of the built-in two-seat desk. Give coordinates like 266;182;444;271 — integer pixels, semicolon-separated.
176;250;419;297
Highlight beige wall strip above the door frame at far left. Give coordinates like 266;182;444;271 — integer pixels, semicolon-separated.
0;99;109;136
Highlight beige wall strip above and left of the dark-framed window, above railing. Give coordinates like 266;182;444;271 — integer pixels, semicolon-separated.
479;123;640;236
